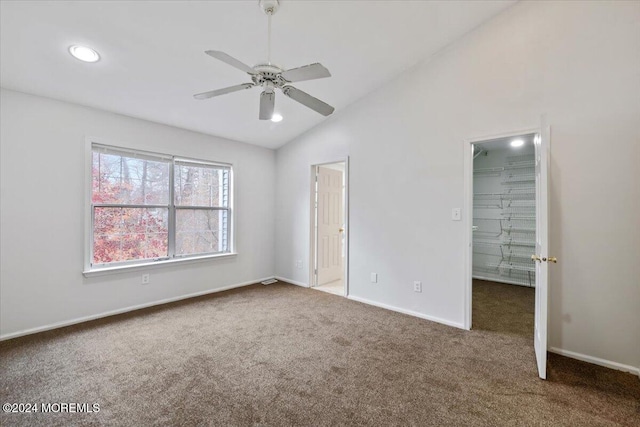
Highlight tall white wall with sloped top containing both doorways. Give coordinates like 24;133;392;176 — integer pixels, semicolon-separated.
276;2;640;367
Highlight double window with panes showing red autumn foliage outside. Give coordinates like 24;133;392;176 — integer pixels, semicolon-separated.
89;144;232;270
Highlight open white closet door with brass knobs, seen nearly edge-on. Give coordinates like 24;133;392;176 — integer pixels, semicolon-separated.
532;123;555;379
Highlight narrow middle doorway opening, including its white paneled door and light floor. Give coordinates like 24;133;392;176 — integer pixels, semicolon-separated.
310;161;347;296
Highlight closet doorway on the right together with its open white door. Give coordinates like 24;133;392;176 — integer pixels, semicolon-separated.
465;125;556;378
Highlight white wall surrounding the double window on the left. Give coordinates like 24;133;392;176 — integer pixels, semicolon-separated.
0;90;275;337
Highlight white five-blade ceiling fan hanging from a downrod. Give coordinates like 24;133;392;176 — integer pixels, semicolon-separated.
193;0;334;120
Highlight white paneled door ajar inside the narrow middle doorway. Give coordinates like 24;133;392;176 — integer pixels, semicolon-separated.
316;166;344;286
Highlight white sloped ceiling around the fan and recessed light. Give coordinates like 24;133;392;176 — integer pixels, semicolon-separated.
0;0;514;148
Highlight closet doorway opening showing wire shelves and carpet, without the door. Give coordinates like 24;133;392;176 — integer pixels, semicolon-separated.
471;134;536;337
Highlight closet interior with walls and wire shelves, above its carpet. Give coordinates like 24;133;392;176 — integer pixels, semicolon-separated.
473;140;536;287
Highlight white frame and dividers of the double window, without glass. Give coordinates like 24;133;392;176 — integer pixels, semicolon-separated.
83;138;237;277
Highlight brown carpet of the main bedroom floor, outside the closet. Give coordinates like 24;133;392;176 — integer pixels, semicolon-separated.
0;284;640;426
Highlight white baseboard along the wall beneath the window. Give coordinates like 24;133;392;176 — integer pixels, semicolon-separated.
0;276;273;341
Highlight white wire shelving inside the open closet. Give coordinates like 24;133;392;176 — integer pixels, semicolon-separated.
473;155;536;287
